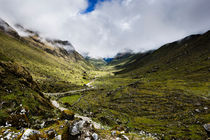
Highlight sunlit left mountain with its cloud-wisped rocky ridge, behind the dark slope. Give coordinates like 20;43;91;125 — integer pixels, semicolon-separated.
0;20;94;92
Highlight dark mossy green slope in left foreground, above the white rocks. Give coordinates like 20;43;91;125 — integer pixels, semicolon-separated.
0;53;55;128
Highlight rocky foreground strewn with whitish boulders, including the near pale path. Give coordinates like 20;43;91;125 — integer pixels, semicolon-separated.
0;101;159;140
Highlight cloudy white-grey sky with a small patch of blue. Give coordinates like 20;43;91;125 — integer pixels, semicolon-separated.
0;0;210;58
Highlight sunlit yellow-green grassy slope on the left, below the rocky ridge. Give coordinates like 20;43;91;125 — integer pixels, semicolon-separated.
0;32;93;91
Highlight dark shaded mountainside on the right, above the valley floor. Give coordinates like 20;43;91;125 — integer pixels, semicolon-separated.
115;31;210;77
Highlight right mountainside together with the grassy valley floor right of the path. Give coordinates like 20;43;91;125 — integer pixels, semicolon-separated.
68;31;210;139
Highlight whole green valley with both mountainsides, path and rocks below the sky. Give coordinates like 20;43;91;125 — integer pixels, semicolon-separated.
0;18;210;140
